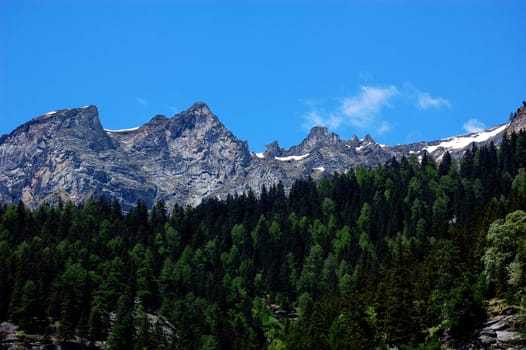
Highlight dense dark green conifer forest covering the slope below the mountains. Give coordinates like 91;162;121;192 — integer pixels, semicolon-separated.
0;132;526;349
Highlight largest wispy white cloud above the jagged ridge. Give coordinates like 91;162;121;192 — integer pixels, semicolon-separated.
304;85;400;134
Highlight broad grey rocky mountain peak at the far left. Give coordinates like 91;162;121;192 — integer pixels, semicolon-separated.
0;106;156;206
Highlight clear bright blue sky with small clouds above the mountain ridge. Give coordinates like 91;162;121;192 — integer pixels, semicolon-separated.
0;0;526;151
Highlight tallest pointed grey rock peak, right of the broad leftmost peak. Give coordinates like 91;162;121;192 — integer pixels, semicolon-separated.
107;103;251;205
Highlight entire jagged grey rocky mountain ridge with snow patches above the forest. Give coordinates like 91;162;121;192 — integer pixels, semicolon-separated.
0;102;526;209
